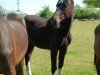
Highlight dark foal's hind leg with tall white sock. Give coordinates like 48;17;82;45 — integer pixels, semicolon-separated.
25;45;34;75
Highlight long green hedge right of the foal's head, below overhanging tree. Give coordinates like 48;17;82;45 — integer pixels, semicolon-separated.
74;6;100;19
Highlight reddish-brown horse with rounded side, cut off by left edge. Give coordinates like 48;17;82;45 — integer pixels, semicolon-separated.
0;13;28;75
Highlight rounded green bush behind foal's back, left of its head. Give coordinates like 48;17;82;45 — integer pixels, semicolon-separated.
38;6;53;19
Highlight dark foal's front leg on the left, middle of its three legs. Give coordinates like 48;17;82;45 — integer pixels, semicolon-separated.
51;49;58;75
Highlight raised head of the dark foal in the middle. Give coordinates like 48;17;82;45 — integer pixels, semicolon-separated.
52;0;74;28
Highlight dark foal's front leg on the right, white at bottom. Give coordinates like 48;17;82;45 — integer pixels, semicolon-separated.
58;47;67;75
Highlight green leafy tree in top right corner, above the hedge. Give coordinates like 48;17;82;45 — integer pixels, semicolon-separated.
83;0;100;8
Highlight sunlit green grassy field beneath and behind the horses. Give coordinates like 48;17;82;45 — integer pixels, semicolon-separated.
22;20;100;75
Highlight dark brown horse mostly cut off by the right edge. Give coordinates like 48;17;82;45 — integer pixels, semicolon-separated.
94;24;100;75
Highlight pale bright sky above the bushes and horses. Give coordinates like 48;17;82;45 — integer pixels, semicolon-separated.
0;0;84;14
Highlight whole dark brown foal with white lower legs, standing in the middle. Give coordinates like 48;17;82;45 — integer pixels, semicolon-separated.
25;0;74;75
